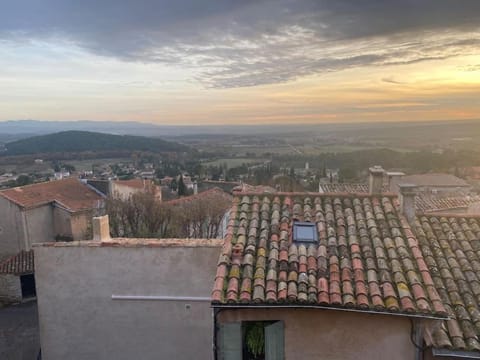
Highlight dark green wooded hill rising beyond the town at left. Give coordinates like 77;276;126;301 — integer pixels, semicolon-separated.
2;131;190;155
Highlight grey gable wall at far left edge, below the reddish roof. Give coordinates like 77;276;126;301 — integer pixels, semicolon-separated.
0;196;26;260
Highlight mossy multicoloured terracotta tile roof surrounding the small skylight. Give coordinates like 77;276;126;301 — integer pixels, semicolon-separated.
212;193;445;315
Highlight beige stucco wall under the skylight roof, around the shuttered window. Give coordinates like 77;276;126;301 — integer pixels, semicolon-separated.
218;309;415;360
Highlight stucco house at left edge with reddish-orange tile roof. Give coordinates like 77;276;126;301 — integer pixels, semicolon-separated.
0;178;103;259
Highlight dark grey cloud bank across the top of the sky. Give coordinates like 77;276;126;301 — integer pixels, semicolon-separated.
0;0;480;87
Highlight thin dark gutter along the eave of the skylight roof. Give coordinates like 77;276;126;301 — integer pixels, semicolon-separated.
212;304;448;320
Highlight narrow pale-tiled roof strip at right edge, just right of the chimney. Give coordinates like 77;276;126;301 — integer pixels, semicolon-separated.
415;194;480;213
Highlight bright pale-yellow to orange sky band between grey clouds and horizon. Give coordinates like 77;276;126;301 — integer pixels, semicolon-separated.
0;42;480;125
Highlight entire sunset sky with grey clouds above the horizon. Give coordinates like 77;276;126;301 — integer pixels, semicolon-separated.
0;0;480;125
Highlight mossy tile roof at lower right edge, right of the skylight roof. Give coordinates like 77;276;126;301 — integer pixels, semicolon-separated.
414;216;480;351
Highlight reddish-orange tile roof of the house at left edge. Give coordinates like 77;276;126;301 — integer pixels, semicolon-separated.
0;178;102;211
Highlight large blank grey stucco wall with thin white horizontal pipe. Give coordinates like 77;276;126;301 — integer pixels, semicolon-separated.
35;240;219;360
